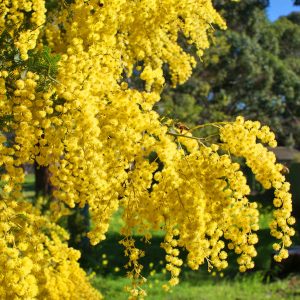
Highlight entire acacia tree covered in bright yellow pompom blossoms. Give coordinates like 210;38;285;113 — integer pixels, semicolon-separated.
0;0;294;299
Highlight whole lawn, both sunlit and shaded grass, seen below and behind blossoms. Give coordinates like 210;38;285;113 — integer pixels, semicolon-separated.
23;175;300;300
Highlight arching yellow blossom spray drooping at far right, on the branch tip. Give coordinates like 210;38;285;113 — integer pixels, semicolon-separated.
220;117;295;261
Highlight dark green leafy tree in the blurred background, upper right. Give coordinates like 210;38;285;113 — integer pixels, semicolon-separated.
158;0;300;147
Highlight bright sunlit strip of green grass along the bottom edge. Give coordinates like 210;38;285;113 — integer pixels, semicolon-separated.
93;273;300;300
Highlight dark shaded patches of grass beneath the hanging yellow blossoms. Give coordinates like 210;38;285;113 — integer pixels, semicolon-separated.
80;229;290;281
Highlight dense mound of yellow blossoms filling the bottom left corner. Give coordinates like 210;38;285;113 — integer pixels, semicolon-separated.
0;198;102;300
